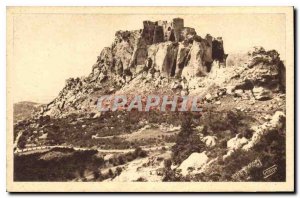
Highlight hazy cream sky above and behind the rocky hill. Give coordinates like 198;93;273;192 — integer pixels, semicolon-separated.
13;14;285;103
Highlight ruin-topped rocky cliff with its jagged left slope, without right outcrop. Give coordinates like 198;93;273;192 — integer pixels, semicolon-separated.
41;18;227;117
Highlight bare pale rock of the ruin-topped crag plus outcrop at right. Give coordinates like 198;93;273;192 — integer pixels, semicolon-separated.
40;18;285;122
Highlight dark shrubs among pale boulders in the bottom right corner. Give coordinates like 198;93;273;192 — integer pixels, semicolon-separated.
163;108;286;182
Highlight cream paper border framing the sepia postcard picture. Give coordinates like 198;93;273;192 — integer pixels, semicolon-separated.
6;7;294;192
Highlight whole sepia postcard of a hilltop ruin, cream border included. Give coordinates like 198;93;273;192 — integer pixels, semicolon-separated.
6;7;295;192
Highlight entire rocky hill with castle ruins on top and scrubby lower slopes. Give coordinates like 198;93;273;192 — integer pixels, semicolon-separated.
14;18;285;181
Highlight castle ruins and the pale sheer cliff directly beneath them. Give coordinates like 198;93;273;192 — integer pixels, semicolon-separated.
135;18;226;77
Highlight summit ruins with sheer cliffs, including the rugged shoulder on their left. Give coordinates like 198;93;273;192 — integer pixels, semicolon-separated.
103;18;226;77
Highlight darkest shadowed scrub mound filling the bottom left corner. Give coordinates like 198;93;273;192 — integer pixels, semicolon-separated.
14;151;99;181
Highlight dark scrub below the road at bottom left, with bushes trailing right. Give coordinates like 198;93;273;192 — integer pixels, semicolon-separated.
14;147;147;181
